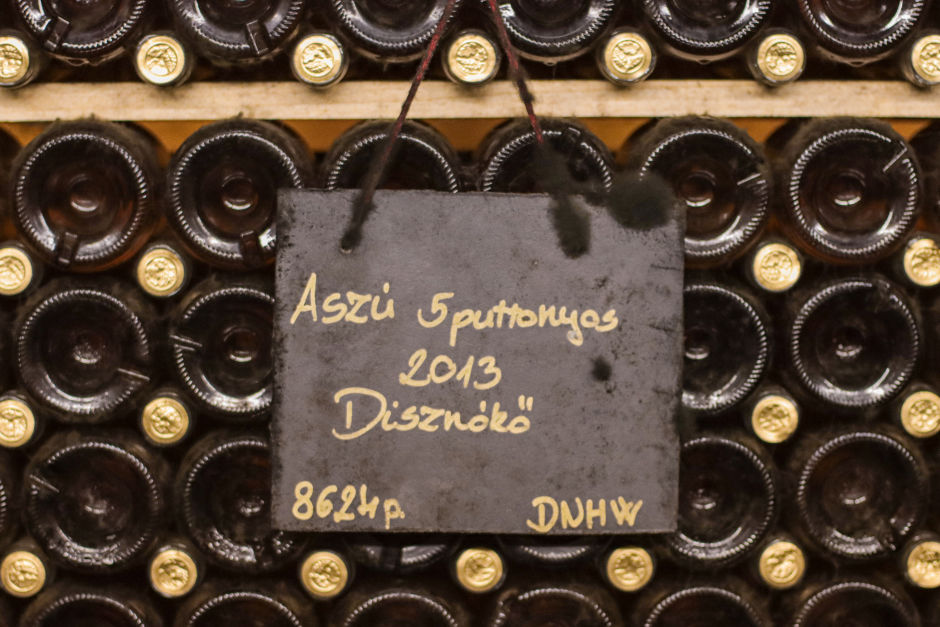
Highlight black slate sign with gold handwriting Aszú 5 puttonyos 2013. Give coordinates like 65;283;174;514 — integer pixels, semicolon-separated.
273;190;683;534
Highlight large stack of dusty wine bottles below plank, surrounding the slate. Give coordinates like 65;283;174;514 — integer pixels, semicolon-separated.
0;118;940;627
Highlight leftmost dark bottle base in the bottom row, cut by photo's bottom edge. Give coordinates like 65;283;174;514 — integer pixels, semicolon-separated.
19;580;163;627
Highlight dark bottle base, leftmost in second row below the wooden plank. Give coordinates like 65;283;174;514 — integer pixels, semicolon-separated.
14;277;156;423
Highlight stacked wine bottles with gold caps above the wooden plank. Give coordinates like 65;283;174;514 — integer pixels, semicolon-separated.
0;0;940;87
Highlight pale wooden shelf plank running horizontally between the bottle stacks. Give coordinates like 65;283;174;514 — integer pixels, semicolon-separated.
0;80;940;122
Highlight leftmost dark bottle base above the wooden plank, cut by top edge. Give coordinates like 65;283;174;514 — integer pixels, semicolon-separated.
10;0;157;65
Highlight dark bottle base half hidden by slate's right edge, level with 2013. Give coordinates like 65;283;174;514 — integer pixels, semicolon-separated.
682;275;772;415
